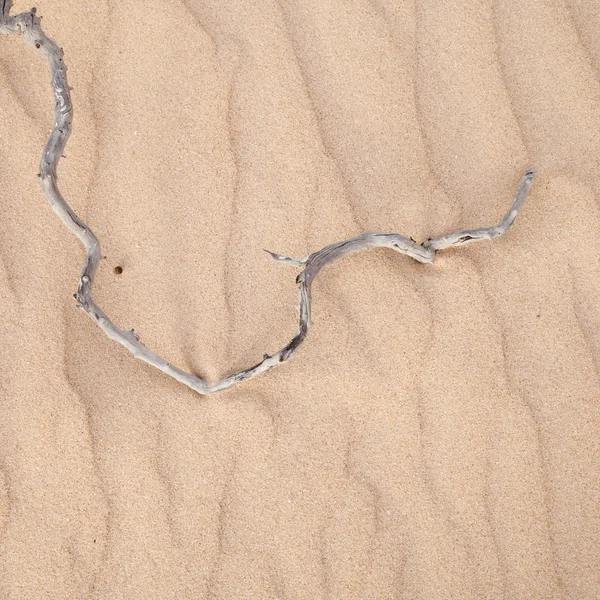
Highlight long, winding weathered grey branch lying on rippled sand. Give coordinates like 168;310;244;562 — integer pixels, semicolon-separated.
0;5;534;395
